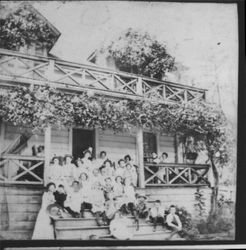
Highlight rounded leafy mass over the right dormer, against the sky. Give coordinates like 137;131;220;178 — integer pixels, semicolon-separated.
102;28;174;79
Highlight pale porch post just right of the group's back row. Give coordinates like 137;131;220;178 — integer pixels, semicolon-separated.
137;127;145;188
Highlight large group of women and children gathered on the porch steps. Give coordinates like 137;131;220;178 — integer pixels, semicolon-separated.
33;148;182;239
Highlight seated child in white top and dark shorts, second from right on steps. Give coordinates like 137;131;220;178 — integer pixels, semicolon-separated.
149;200;165;232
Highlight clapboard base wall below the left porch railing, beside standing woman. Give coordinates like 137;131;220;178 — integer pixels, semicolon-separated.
0;185;43;239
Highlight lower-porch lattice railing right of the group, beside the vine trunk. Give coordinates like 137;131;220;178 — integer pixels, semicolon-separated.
144;163;210;186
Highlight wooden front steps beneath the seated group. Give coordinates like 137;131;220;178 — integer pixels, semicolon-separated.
55;212;183;240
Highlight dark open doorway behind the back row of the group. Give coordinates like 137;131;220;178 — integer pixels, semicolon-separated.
72;128;95;159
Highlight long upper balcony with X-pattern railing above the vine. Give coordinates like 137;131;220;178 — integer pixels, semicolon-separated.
0;49;206;103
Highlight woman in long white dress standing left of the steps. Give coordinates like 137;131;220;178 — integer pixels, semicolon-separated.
32;182;56;240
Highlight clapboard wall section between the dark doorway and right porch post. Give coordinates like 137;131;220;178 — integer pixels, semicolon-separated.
98;131;137;163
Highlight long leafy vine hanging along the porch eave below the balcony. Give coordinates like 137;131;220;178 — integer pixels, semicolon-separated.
0;85;231;164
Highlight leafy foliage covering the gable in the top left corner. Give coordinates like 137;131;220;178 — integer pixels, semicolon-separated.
0;5;56;50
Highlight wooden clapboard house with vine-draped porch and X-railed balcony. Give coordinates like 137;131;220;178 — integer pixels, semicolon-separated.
0;2;212;239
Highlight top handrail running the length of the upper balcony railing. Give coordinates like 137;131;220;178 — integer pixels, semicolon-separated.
0;49;207;93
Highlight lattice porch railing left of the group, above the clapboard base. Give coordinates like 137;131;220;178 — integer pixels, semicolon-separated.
0;154;44;184
